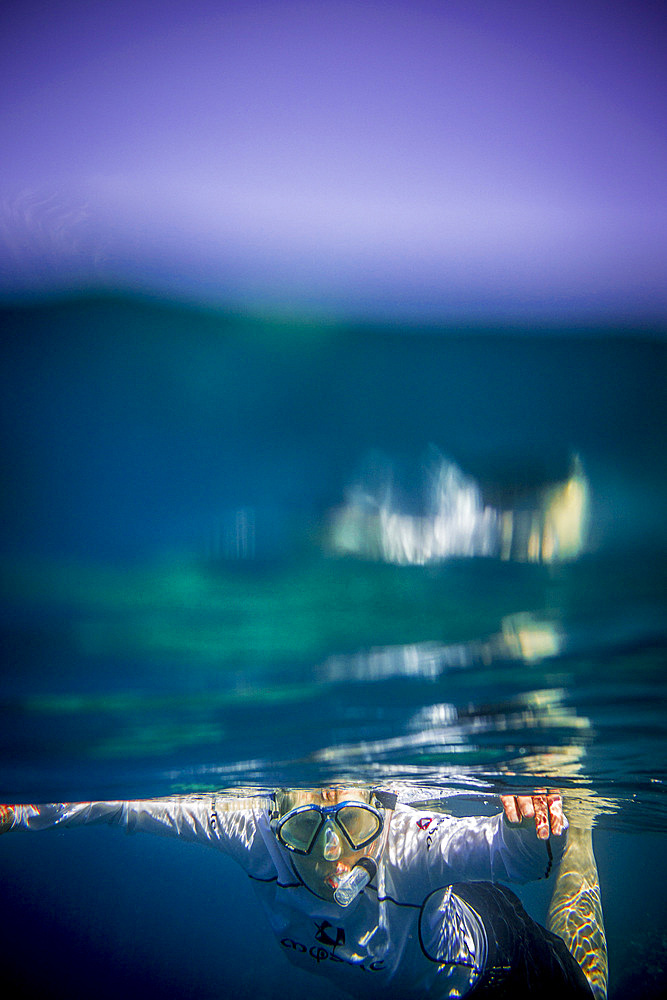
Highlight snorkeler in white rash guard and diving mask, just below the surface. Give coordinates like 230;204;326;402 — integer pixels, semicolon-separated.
0;788;606;1000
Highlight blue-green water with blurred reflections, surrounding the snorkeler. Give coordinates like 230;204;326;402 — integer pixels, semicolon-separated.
0;298;667;998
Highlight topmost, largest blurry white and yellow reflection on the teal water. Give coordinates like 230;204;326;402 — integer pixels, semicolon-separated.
329;456;589;566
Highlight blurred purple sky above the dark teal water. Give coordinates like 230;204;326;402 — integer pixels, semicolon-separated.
0;0;667;319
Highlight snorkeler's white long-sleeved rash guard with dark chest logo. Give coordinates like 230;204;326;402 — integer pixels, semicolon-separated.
7;795;567;998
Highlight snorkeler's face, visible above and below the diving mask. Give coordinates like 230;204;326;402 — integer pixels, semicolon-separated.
280;788;372;900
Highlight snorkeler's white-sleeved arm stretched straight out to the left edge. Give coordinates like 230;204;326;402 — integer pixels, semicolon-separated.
0;795;268;871
